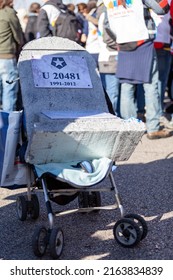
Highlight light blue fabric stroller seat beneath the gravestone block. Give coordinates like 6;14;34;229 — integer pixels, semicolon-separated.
35;158;112;187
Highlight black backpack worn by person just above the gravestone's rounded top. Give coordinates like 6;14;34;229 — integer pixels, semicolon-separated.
52;8;82;43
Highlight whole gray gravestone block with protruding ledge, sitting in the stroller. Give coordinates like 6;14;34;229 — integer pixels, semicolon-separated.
18;37;145;164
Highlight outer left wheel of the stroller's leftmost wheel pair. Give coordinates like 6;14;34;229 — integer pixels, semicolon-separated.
16;195;28;221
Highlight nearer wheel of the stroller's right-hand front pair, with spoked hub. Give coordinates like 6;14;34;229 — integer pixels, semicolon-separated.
113;218;142;248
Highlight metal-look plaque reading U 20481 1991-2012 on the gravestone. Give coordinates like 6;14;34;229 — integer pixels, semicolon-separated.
31;54;93;88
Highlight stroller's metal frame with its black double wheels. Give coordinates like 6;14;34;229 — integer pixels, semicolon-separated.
16;162;148;259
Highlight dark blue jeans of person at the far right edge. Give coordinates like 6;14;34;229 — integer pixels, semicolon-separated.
156;49;172;115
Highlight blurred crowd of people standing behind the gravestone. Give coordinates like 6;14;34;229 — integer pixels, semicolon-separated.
0;0;173;139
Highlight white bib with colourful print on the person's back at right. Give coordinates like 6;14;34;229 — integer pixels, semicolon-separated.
103;0;149;44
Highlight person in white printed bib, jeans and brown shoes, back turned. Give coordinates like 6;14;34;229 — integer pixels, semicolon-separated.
104;0;171;139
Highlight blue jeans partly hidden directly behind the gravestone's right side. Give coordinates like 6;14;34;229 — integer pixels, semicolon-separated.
100;73;120;116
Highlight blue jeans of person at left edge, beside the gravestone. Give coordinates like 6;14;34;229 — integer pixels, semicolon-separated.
0;58;19;111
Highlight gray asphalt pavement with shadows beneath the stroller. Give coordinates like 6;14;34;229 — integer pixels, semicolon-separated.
0;135;173;260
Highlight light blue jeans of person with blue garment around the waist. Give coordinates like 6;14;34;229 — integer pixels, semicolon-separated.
120;53;161;133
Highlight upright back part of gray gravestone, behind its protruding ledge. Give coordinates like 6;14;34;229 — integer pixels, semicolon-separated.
18;37;108;139
